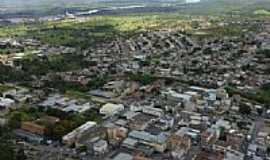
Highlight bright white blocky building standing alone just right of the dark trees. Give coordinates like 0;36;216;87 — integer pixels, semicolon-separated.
99;103;125;116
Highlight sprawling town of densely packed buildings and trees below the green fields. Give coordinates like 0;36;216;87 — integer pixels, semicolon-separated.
0;0;270;160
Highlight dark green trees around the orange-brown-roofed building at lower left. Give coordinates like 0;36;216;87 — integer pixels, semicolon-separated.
8;106;102;139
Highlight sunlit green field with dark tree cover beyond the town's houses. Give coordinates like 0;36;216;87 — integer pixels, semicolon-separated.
0;14;192;48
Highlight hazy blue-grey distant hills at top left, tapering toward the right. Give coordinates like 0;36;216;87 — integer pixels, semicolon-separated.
0;0;188;16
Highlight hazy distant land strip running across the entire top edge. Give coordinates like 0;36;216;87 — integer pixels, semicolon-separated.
0;0;270;16
